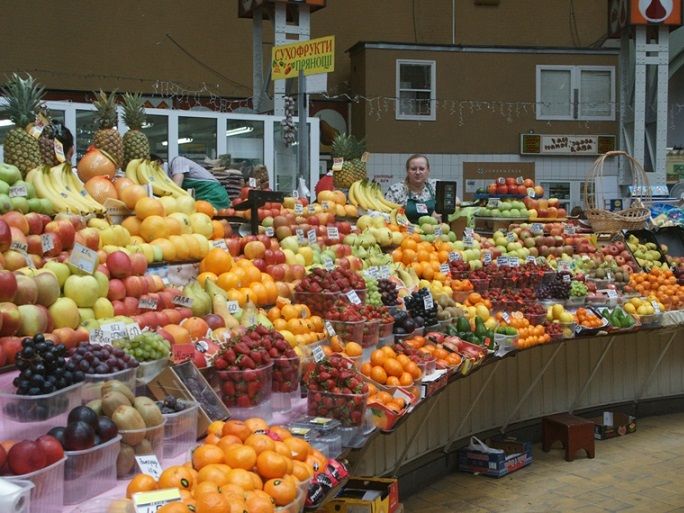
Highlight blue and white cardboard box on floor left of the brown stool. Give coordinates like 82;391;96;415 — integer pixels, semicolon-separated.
458;438;532;477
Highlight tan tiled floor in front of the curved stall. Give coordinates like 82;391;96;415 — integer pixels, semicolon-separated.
404;414;684;513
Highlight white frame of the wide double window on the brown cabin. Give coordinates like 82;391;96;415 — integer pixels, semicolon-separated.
535;64;616;121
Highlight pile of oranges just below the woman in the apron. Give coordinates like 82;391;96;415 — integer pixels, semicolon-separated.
392;233;451;282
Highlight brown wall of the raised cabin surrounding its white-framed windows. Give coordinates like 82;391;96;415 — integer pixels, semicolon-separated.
352;49;617;154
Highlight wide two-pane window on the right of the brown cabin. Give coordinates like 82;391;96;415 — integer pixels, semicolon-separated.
537;66;615;121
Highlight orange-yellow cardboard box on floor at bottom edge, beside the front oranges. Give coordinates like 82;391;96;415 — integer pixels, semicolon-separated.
323;477;399;513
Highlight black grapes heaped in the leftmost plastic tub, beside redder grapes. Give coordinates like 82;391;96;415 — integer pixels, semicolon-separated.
14;333;85;396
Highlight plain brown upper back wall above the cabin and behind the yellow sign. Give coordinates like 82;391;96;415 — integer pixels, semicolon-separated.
0;0;607;97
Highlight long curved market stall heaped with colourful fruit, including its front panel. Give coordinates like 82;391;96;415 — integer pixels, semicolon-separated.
0;77;684;513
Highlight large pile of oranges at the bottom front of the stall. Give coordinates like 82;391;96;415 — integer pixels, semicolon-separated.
126;418;328;513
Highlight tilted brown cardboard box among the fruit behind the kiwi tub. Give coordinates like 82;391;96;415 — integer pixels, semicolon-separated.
147;361;230;437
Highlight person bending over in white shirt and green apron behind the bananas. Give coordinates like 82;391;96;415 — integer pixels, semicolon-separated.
150;155;230;209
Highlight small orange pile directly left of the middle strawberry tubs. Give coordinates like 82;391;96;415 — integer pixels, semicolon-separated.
266;298;325;347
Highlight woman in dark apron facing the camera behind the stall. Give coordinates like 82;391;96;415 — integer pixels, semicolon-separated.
385;153;437;223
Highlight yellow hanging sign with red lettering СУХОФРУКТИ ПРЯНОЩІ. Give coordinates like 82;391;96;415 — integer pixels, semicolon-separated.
271;36;335;80
